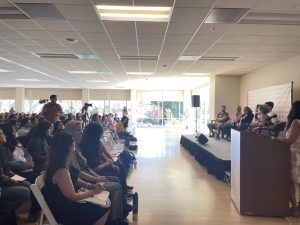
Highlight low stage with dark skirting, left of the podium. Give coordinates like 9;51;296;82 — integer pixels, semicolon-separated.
180;135;231;180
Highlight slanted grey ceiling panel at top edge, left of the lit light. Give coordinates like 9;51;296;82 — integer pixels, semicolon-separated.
15;3;65;20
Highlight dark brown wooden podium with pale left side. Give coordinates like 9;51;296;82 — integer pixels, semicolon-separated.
231;129;291;217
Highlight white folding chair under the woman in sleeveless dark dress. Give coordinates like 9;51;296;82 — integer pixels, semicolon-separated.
30;175;59;225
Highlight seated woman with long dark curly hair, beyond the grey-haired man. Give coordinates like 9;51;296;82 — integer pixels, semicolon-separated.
79;123;132;193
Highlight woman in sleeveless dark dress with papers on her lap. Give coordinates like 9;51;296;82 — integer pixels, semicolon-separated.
42;132;109;225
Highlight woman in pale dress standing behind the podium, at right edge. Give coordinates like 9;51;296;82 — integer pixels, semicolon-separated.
271;101;300;217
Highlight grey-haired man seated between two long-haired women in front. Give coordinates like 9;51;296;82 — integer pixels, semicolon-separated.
65;121;130;222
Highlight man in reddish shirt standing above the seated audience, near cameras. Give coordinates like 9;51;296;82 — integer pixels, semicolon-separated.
42;95;63;123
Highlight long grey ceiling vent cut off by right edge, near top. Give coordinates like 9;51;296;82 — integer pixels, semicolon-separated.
239;12;300;25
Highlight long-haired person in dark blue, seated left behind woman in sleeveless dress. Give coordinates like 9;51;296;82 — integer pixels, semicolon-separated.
27;120;51;176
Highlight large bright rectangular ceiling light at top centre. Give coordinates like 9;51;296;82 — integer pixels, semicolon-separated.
96;5;172;22
